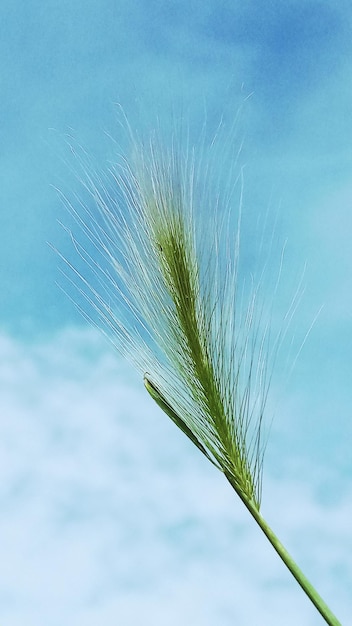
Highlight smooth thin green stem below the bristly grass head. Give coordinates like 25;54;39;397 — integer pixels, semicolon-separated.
227;476;342;626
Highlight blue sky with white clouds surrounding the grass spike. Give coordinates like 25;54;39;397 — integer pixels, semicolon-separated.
0;0;352;626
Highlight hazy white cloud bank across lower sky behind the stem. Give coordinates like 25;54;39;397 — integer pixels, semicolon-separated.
0;329;352;626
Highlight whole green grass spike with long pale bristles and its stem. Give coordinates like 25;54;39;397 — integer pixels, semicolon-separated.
59;113;339;626
